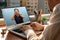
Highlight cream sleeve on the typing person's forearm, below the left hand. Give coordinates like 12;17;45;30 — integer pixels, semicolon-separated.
25;29;40;40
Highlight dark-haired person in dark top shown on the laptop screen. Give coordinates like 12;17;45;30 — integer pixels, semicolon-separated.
11;9;25;24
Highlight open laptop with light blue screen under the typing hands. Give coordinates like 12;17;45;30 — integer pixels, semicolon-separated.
2;7;40;38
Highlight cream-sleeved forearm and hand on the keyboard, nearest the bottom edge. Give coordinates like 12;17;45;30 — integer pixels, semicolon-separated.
20;25;39;40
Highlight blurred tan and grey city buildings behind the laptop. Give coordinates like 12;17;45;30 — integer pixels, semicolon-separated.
0;0;50;18
